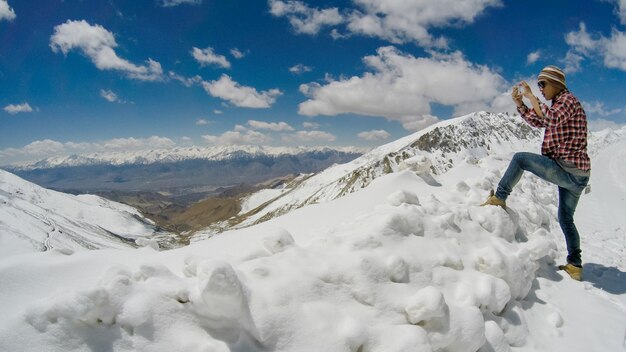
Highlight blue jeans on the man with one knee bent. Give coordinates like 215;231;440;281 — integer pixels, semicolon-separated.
496;153;589;266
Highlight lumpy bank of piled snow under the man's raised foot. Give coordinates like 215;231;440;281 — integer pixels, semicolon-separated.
0;173;562;352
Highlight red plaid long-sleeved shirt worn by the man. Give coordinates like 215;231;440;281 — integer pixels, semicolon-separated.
518;89;591;171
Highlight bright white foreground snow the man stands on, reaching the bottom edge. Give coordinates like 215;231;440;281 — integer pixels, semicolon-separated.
0;116;626;352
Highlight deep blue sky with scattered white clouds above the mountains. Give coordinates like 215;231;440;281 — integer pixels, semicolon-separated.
0;0;626;165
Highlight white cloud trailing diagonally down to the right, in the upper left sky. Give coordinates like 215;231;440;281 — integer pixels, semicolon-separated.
50;20;163;81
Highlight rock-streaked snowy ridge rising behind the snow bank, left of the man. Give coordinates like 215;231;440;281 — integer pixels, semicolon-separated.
224;112;542;235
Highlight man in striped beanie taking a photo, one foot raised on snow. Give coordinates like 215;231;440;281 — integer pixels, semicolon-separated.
483;66;591;281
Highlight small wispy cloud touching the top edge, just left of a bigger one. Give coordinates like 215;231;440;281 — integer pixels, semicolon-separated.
269;0;343;35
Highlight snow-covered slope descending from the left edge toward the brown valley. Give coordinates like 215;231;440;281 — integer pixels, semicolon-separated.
0;170;172;258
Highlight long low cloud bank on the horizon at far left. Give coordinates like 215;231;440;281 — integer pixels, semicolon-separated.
0;136;176;164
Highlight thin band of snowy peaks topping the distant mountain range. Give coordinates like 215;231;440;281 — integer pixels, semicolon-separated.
12;146;367;170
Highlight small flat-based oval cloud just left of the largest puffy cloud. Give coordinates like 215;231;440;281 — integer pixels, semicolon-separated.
202;75;282;108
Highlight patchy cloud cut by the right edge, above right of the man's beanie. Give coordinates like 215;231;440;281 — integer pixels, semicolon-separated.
564;23;626;72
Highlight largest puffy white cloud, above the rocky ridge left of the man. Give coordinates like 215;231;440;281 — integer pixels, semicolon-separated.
299;46;510;130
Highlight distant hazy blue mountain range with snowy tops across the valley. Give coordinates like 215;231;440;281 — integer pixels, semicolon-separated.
3;146;364;199
